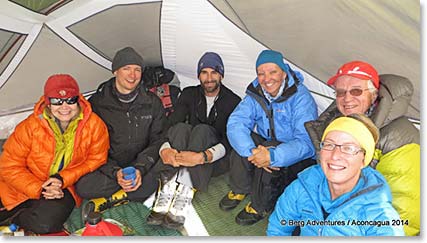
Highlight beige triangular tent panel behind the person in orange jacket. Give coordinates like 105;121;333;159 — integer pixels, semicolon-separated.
0;27;111;110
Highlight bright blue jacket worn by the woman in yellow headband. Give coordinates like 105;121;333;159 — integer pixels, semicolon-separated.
267;165;404;236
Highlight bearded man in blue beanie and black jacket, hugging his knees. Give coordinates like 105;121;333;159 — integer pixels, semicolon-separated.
147;52;241;229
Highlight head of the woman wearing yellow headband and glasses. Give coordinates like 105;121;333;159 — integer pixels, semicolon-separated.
319;114;379;199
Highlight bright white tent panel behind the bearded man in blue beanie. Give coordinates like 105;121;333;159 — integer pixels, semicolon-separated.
161;0;333;112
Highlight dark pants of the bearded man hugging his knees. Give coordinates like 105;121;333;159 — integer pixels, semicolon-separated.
155;123;229;191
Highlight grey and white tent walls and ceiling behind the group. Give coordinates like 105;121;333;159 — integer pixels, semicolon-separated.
0;0;421;235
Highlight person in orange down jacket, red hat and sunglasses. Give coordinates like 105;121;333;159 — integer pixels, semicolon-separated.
0;74;109;234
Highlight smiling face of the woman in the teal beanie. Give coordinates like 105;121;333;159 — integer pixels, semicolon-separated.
257;62;286;97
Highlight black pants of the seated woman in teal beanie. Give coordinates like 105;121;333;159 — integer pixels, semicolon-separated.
230;133;316;212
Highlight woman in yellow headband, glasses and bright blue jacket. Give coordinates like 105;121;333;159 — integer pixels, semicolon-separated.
267;114;408;236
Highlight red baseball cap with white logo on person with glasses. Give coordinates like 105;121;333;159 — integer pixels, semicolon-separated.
327;61;380;89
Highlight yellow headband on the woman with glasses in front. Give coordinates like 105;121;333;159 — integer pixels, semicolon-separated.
322;117;375;166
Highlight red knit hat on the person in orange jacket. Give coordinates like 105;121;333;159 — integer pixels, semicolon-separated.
44;74;80;104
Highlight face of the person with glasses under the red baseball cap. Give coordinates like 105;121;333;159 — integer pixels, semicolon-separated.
335;75;376;115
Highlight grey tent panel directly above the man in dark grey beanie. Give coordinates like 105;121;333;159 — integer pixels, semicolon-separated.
69;2;162;65
